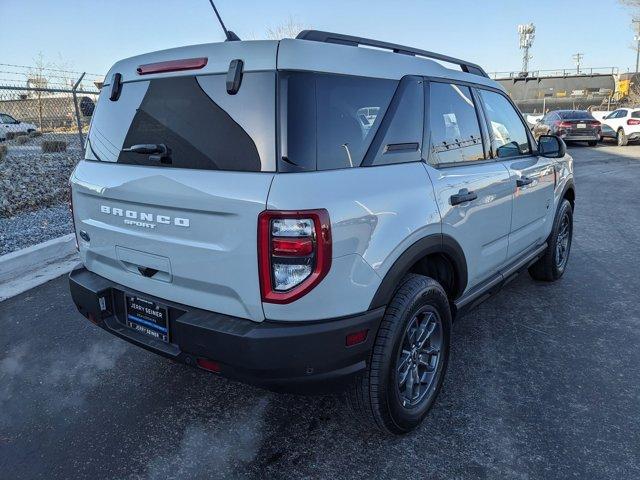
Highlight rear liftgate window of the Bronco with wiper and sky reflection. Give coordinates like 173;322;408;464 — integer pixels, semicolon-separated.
87;72;275;172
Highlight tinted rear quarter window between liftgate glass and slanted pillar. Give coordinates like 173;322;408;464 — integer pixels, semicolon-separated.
279;72;398;171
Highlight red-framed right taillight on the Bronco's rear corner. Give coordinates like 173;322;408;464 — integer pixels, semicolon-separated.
258;209;331;303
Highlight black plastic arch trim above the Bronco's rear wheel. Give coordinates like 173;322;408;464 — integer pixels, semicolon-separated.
369;234;467;310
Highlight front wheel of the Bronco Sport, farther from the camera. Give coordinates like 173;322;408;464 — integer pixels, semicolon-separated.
529;199;573;282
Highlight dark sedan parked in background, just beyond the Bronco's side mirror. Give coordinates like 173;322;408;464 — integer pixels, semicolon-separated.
533;110;600;147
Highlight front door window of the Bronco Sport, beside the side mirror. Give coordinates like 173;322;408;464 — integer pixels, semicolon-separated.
480;90;531;158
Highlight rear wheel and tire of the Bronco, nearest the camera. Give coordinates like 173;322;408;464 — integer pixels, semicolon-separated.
349;274;452;434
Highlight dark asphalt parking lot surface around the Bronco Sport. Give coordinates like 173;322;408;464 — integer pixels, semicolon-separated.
0;146;640;479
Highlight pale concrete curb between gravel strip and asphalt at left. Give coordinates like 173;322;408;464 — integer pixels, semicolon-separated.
0;233;79;302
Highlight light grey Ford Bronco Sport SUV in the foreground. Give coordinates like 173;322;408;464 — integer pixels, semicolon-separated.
69;31;575;433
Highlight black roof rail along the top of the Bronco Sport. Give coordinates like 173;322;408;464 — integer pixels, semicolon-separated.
296;30;489;78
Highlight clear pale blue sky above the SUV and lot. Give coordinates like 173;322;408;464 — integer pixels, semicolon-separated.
0;0;635;74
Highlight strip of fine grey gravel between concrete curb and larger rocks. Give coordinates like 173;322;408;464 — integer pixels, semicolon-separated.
0;204;73;255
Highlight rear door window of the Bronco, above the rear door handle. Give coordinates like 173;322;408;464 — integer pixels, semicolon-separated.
429;82;485;165
